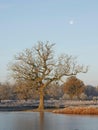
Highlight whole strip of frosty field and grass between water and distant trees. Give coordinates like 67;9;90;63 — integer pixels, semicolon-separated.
0;100;98;115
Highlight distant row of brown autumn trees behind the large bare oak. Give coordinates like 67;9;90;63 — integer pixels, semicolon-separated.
0;77;98;101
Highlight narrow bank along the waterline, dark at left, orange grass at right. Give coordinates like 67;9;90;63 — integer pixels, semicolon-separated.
0;105;98;115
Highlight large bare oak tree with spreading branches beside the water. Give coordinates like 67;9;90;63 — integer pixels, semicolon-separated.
10;41;87;110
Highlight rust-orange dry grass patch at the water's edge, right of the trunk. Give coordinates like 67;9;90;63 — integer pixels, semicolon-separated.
53;107;98;115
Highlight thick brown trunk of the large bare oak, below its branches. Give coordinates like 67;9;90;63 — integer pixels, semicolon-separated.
38;87;44;110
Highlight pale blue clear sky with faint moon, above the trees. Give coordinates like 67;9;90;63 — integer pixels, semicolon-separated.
0;0;98;85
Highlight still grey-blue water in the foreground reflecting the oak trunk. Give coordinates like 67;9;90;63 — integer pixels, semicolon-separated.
0;112;98;130
